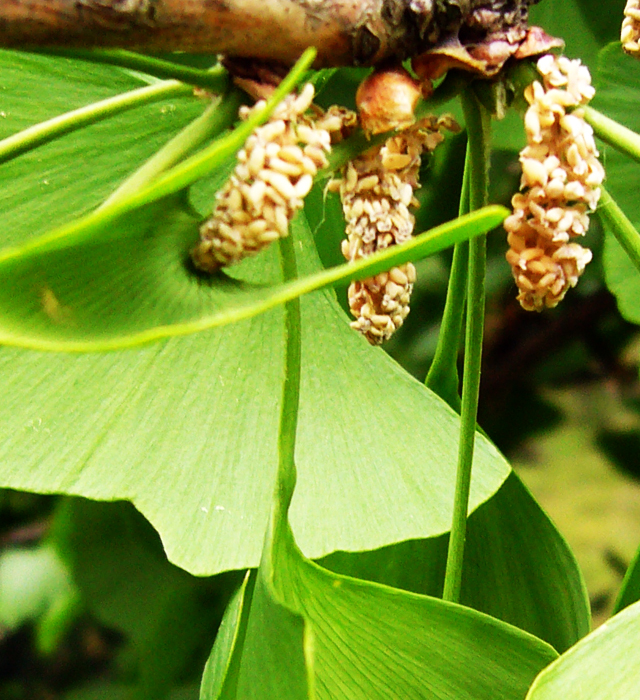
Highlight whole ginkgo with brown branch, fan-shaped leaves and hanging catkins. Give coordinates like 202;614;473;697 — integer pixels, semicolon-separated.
0;0;640;700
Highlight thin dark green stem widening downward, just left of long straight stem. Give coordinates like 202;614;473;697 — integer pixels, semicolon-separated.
425;145;470;412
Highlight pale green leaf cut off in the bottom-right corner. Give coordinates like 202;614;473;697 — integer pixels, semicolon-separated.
527;603;640;700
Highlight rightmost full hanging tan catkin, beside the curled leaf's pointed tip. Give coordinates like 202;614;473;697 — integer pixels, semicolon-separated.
504;54;604;311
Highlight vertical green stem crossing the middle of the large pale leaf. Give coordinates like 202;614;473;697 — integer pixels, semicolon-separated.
278;236;302;514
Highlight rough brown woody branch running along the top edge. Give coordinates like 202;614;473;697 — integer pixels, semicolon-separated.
0;0;538;67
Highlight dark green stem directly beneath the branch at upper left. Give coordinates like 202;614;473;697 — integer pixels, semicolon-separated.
34;49;228;93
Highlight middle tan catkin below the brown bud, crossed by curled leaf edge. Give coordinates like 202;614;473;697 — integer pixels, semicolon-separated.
334;116;458;344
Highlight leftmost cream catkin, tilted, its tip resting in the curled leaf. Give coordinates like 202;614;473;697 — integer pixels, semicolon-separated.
191;84;355;272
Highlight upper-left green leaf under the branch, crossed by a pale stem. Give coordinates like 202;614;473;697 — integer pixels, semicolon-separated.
0;51;205;247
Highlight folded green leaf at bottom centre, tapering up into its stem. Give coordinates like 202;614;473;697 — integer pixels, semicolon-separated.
201;482;556;700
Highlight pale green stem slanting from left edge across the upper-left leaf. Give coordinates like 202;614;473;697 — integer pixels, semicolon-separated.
0;81;192;163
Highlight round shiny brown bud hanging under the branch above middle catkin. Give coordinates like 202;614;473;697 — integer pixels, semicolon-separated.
356;66;421;134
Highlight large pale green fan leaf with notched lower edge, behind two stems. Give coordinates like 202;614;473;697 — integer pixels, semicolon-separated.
0;221;509;574
